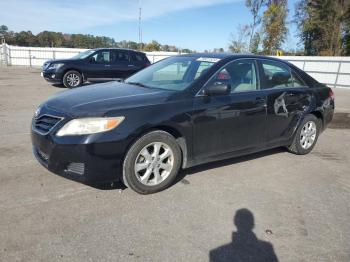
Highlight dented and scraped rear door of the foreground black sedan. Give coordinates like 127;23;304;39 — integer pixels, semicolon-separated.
259;59;312;144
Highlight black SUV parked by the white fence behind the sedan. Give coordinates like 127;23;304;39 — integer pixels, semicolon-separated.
41;48;151;88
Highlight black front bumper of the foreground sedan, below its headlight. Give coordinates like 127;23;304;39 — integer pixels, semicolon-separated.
31;123;127;184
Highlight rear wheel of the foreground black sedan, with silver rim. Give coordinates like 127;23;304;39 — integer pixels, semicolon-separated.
287;114;321;155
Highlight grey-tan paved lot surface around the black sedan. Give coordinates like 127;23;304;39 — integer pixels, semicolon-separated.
0;67;350;261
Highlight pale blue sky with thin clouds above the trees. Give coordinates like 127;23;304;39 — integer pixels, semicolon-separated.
0;0;297;51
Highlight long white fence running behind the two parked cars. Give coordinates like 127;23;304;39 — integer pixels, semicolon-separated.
0;44;350;88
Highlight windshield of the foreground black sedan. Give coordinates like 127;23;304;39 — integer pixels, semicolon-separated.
125;56;219;91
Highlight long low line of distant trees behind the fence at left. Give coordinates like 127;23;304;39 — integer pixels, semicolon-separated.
0;25;193;53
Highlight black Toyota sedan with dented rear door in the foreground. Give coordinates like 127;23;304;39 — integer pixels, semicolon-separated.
32;54;334;194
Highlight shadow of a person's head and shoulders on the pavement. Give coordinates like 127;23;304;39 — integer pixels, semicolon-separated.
209;209;278;262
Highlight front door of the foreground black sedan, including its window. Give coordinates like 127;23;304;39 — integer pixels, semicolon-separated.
193;59;266;158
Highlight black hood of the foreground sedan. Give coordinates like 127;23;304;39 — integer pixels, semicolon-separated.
44;82;174;117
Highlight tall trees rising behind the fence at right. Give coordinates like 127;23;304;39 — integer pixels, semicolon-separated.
229;0;350;56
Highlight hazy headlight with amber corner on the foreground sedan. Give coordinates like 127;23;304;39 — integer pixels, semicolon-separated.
57;116;125;136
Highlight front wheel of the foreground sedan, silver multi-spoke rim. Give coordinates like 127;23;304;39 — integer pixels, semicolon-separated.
123;131;182;195
